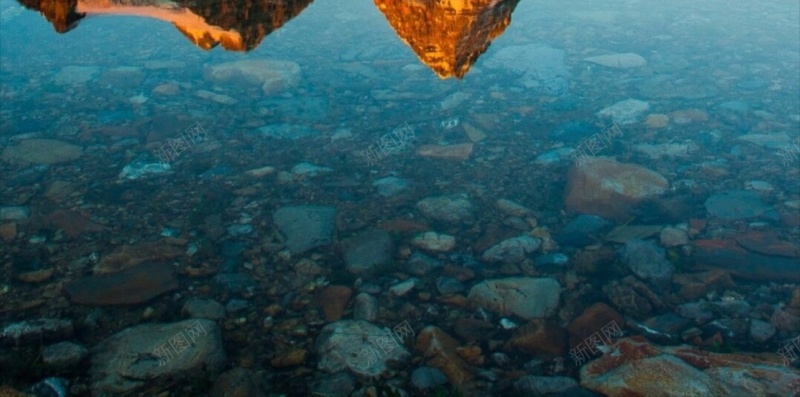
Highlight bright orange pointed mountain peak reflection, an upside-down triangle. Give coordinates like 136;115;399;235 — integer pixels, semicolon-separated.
374;0;519;78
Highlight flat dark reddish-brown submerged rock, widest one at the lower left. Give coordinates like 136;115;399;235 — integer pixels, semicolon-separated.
64;264;178;306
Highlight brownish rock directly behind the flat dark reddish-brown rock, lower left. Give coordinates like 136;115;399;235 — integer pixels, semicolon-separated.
94;241;184;274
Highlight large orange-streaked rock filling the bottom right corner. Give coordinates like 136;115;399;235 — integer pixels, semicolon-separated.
580;336;800;397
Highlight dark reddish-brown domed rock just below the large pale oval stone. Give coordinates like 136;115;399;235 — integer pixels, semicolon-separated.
506;318;567;357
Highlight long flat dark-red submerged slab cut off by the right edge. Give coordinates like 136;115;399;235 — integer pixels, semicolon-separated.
695;240;800;282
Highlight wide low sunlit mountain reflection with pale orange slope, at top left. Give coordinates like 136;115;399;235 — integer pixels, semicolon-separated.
19;0;313;51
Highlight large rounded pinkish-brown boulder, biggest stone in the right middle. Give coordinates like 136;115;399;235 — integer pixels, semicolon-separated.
565;157;669;221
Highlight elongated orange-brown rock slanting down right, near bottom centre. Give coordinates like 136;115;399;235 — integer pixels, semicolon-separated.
416;325;472;385
